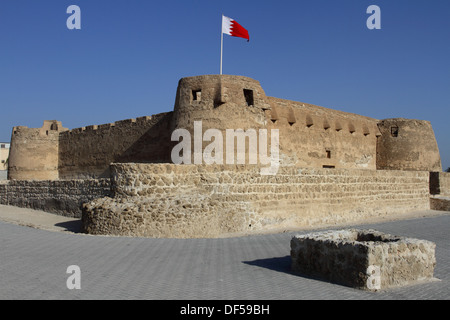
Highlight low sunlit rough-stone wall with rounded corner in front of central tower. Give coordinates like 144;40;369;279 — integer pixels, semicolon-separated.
82;164;430;238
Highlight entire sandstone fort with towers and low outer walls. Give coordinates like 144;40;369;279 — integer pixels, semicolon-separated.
0;75;450;238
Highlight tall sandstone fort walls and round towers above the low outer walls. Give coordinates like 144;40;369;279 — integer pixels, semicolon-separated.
9;75;442;180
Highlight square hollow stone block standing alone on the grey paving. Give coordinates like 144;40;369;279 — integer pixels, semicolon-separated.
291;229;436;291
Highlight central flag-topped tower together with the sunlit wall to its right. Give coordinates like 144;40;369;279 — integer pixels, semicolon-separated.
172;75;380;170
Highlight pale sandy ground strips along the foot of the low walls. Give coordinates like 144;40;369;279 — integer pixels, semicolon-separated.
0;205;450;237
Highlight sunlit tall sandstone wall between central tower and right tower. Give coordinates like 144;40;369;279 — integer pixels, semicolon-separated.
266;97;381;170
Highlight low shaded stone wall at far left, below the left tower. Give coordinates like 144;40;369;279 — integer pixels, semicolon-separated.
0;179;111;218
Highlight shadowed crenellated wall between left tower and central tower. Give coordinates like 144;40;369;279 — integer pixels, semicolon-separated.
59;113;171;179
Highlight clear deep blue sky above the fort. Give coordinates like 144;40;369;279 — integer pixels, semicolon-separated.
0;0;450;169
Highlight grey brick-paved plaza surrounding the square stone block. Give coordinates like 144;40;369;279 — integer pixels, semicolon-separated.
0;206;450;300
